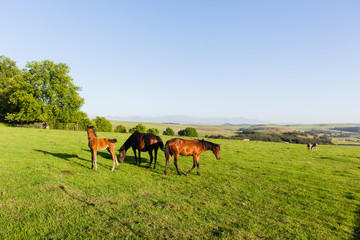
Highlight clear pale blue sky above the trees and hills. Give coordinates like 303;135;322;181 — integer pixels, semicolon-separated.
0;0;360;123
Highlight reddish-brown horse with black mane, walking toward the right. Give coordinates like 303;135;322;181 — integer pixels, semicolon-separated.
164;138;220;176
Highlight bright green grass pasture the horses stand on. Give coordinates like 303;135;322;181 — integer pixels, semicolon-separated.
0;125;360;239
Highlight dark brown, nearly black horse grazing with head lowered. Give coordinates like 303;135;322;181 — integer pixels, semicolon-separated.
119;132;164;169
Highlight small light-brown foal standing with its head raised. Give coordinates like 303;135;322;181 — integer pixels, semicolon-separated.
87;126;119;171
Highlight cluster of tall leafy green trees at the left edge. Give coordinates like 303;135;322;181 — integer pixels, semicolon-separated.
0;56;90;128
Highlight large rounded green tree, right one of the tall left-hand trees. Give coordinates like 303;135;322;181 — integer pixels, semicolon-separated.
23;60;84;124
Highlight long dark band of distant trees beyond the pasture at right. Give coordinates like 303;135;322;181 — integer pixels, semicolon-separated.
206;130;333;144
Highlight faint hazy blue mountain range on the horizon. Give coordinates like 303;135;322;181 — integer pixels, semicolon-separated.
100;116;267;125
